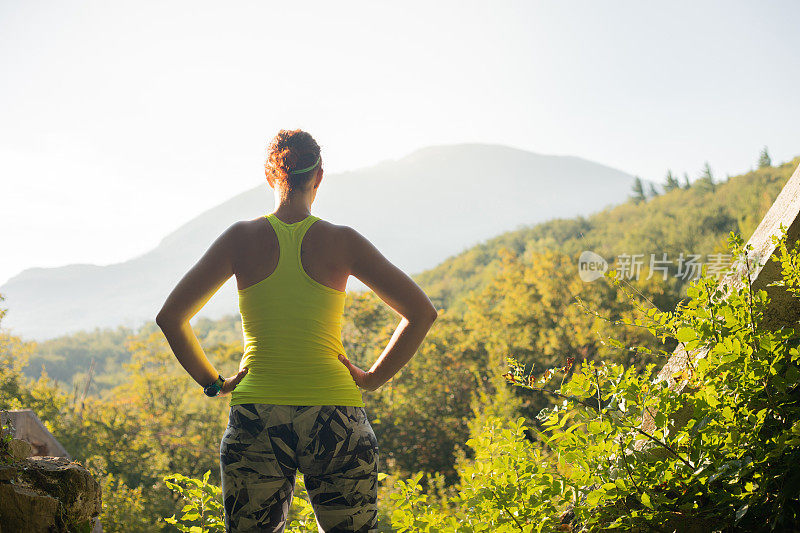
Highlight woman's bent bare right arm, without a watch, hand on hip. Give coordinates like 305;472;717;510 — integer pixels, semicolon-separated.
339;228;438;390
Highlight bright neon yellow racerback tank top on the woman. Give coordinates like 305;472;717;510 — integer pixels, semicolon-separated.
230;213;364;407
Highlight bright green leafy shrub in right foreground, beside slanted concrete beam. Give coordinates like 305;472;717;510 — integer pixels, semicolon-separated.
392;230;800;532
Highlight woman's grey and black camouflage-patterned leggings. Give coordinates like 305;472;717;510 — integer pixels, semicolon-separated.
220;403;378;533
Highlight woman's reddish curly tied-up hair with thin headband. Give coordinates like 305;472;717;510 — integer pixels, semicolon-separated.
264;129;322;196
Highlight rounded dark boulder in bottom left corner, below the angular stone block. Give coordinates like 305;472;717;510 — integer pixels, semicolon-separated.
0;457;101;533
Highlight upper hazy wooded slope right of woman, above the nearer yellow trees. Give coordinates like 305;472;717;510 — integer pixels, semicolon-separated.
417;158;800;309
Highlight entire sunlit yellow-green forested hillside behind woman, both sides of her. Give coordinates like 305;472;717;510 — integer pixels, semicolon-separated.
0;154;800;531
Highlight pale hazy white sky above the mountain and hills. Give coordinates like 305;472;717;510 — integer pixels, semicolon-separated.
0;0;800;284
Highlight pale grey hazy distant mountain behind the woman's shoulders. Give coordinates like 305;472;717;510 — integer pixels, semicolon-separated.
0;144;633;340
